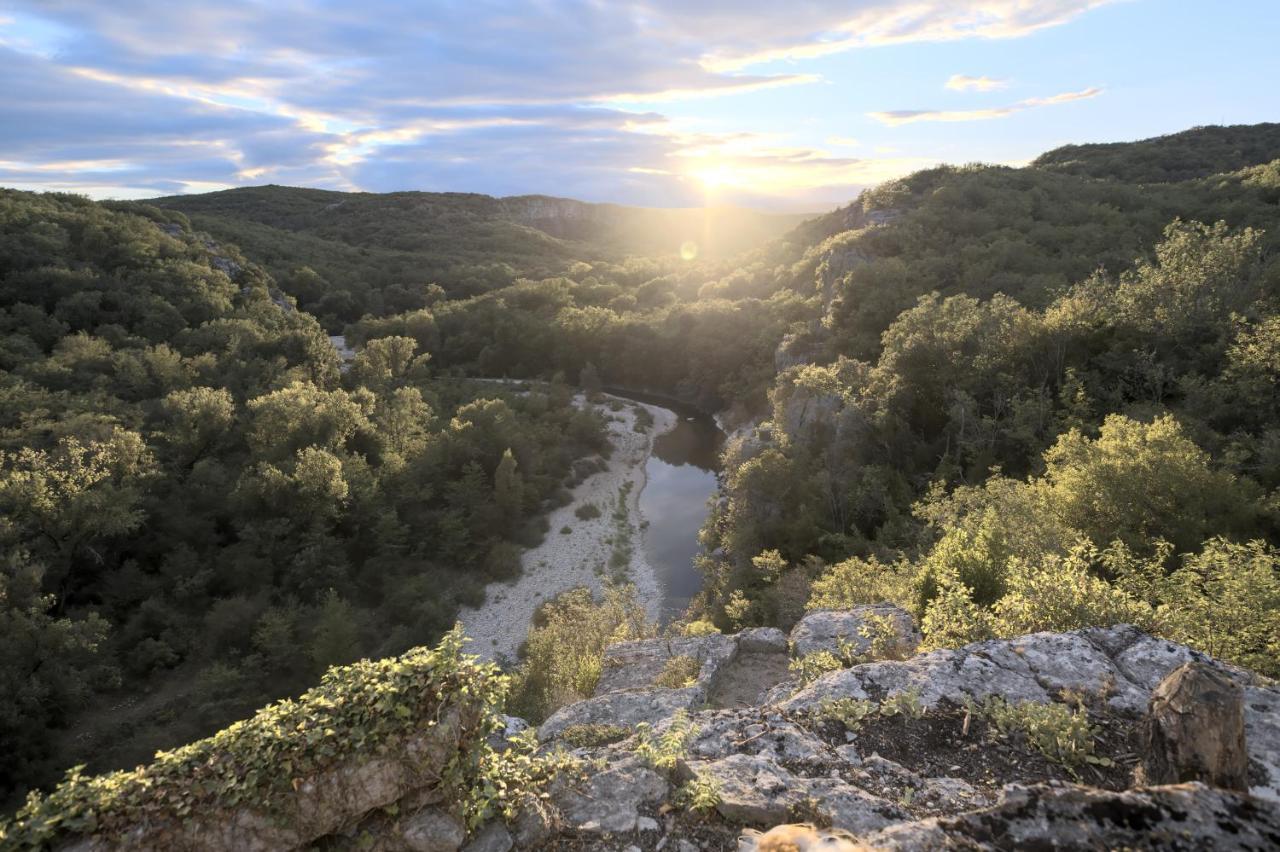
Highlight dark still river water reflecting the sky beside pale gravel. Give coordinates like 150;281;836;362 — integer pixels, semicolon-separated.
608;389;724;620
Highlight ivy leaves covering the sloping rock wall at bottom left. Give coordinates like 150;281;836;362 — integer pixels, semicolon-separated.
0;631;504;848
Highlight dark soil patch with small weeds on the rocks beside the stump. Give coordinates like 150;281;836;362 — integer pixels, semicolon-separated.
805;706;1138;801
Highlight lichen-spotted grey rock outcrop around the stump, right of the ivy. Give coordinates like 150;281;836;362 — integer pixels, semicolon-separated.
514;605;1280;849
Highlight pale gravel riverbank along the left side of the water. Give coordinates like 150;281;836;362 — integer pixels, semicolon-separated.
458;394;676;660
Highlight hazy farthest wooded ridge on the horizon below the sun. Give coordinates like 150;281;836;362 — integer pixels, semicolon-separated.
148;185;804;330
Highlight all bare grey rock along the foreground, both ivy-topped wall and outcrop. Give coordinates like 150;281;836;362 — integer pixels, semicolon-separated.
20;614;1280;852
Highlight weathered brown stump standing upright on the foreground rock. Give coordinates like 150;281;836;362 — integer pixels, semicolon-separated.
1138;663;1249;791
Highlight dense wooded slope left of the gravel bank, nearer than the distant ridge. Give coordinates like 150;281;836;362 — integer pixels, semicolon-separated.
0;191;608;800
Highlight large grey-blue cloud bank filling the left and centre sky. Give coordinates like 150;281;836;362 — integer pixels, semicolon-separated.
0;0;1110;203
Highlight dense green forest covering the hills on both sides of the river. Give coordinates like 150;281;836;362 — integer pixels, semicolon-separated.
0;124;1280;798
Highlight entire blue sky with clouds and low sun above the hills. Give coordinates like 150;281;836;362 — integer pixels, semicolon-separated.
0;0;1280;211
